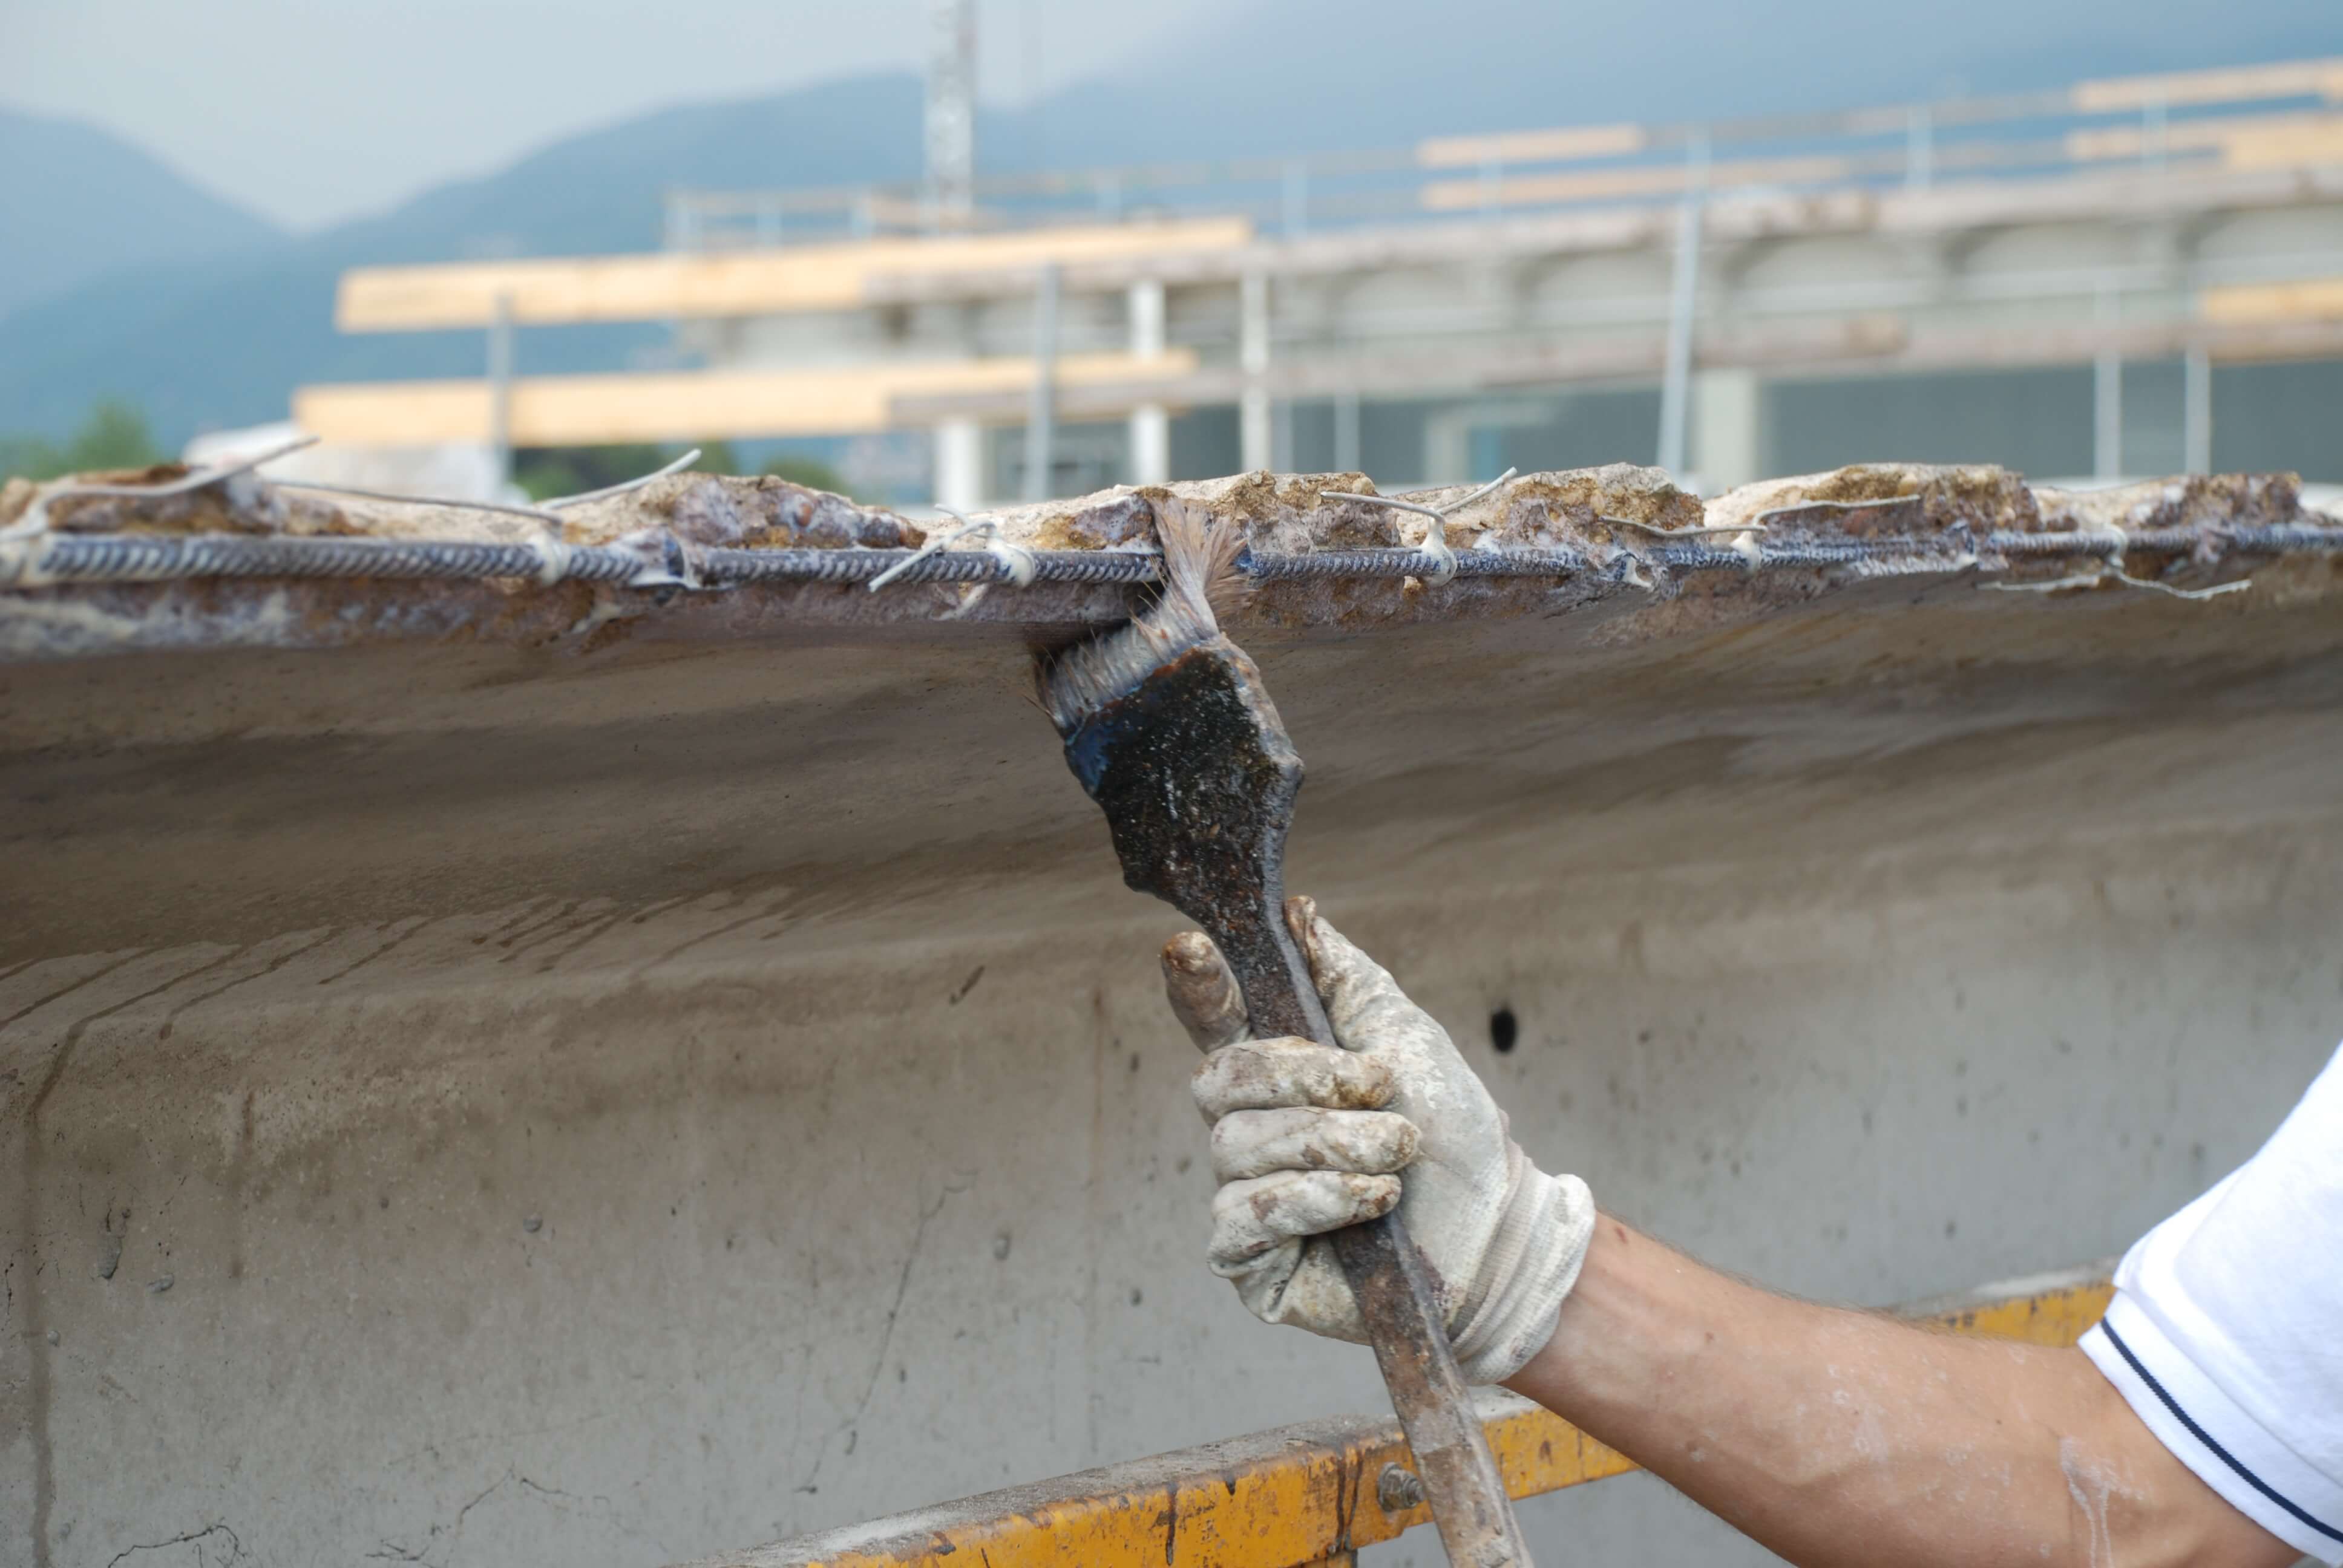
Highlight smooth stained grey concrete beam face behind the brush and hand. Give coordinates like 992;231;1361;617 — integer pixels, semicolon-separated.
0;563;2343;1568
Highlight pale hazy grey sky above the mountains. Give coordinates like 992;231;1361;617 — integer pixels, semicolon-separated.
0;0;1233;227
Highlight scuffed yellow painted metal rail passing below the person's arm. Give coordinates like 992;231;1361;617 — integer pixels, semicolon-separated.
675;1266;2111;1568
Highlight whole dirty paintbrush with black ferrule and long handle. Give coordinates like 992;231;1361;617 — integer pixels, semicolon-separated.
1038;499;1530;1568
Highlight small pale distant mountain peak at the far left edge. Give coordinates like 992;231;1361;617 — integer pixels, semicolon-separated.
0;108;281;316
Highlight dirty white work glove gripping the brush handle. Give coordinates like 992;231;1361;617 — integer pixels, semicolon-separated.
1162;898;1596;1383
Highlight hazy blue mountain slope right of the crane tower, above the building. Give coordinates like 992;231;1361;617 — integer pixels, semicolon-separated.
979;0;2343;166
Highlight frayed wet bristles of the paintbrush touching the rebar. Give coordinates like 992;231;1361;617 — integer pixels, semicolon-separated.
1038;497;1251;736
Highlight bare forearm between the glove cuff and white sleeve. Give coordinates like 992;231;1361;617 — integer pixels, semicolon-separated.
1511;1217;2292;1568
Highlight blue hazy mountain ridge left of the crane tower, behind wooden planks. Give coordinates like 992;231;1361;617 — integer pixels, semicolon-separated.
0;75;921;445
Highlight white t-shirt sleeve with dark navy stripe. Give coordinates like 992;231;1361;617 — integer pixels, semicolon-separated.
2083;1050;2343;1563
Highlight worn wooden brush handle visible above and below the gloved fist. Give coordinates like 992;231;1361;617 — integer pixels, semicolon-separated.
1209;886;1530;1568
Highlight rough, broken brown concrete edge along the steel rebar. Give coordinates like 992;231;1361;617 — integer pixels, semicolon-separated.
0;464;2334;661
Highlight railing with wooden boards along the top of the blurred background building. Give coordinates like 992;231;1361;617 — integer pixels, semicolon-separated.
666;59;2343;251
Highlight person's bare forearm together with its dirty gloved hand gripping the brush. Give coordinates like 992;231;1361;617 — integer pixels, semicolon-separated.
1164;900;2294;1568
